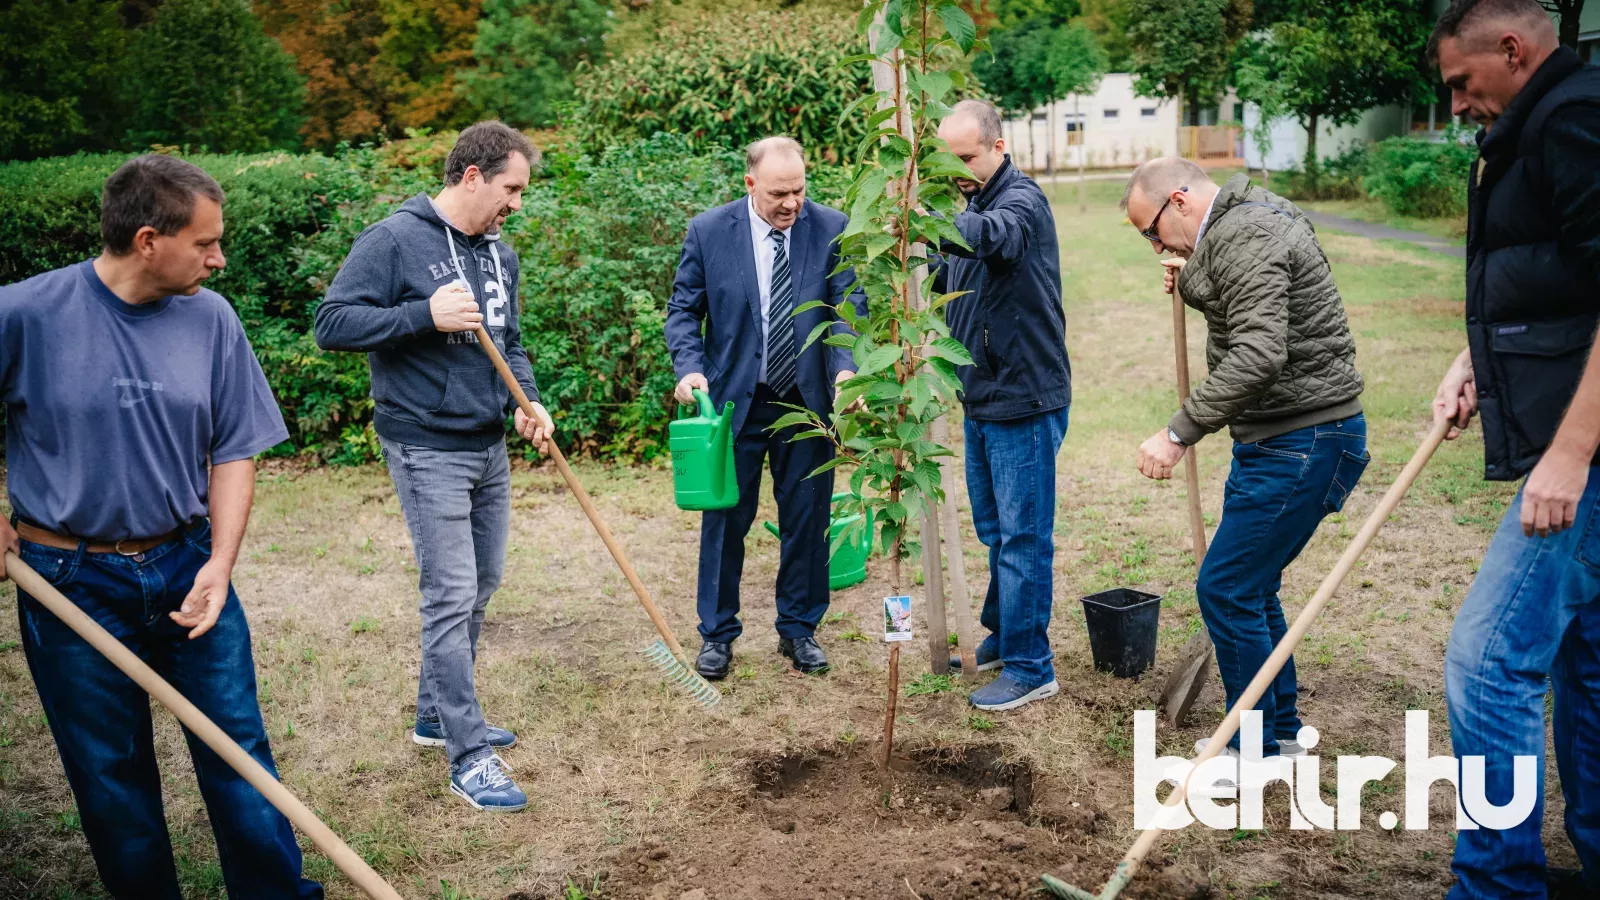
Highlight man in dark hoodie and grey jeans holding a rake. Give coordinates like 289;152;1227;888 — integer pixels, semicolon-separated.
315;120;554;812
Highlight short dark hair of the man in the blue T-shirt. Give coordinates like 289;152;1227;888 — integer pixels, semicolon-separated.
101;154;222;256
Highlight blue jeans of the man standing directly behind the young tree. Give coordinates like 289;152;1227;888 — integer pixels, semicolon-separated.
965;407;1069;689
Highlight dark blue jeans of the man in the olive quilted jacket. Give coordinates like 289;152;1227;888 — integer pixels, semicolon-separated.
1195;415;1371;756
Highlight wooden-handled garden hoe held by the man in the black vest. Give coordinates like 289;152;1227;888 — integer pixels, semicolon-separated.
1040;418;1450;900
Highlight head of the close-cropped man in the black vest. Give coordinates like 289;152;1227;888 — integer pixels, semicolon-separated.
1427;0;1560;128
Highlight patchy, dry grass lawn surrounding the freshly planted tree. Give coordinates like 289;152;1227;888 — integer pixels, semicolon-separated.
0;175;1548;900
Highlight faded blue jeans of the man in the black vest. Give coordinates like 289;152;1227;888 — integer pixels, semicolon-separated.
1445;466;1600;900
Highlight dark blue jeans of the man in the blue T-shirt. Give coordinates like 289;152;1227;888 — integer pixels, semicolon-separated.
18;524;322;900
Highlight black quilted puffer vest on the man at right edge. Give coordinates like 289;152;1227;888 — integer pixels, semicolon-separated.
1466;48;1600;480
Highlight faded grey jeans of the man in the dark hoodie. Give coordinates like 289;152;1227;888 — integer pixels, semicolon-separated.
382;439;510;773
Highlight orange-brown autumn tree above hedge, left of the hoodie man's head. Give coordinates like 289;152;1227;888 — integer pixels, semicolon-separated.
254;0;400;149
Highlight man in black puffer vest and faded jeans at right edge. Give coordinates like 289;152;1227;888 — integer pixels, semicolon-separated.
1429;0;1600;900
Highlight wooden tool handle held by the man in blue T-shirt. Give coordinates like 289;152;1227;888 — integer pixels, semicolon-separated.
5;551;400;900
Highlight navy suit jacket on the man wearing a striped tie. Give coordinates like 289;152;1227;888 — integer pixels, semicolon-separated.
666;195;867;434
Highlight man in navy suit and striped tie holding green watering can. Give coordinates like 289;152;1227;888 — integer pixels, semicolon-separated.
666;138;866;679
